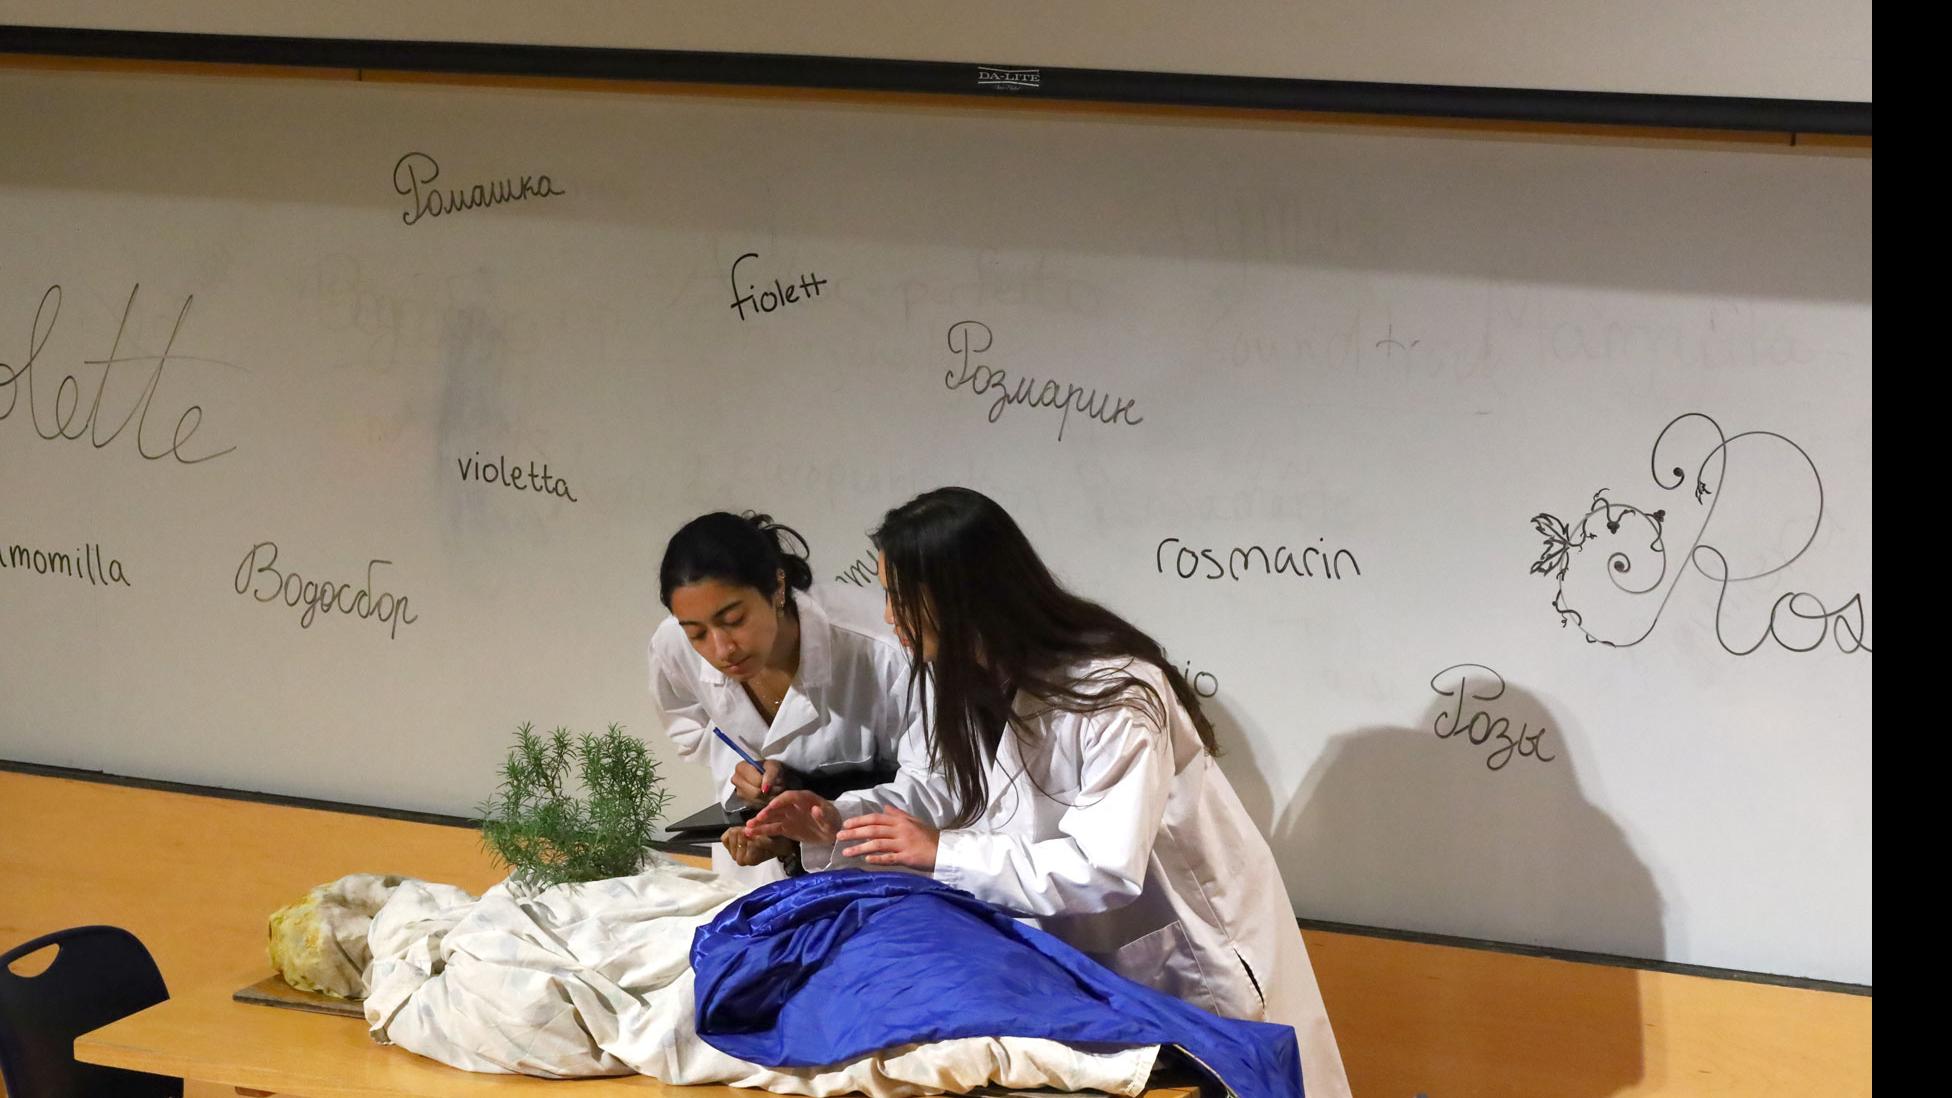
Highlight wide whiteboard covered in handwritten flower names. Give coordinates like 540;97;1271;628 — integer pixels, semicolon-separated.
0;72;1874;985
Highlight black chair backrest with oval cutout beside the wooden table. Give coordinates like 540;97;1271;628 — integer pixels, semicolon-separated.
0;926;183;1098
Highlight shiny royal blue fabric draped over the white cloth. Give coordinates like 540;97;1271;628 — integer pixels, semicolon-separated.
691;869;1302;1098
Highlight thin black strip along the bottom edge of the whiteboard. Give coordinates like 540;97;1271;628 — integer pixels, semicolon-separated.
11;758;1870;998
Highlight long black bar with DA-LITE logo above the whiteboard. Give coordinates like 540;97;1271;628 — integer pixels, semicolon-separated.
0;25;1870;137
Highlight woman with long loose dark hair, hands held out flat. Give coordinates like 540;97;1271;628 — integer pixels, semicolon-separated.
746;488;1349;1098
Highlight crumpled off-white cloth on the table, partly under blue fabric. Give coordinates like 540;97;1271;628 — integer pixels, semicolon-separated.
365;860;1158;1098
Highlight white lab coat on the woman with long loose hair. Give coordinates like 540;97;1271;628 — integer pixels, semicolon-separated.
804;660;1349;1098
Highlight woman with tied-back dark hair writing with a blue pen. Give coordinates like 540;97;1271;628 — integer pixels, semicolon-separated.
650;512;948;885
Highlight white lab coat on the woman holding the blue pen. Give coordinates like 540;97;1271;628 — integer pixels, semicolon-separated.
650;588;935;887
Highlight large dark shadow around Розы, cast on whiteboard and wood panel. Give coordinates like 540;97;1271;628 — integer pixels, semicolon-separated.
1208;666;1665;1098
